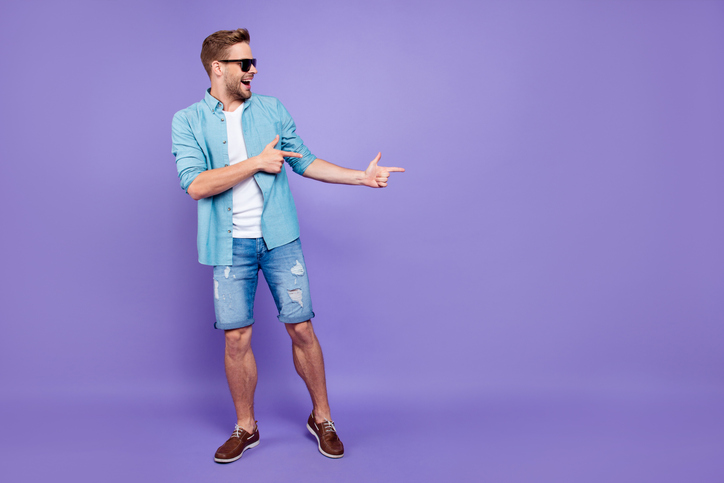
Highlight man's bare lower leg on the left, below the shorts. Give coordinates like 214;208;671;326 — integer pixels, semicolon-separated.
224;326;257;433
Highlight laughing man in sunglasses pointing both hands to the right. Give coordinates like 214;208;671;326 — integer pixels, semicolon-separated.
172;29;404;463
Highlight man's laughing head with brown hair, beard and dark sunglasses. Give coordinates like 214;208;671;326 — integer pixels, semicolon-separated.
201;29;257;101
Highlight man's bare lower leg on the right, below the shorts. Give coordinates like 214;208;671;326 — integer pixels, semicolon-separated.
285;320;332;423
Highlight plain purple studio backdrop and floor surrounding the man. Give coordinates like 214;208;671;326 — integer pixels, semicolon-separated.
0;0;724;483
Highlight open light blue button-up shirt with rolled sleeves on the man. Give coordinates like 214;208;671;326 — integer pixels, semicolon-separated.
171;89;316;265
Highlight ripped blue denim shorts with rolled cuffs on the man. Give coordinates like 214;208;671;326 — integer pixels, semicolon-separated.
214;238;314;330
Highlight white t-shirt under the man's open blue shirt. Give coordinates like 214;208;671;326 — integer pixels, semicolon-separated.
224;103;264;238
